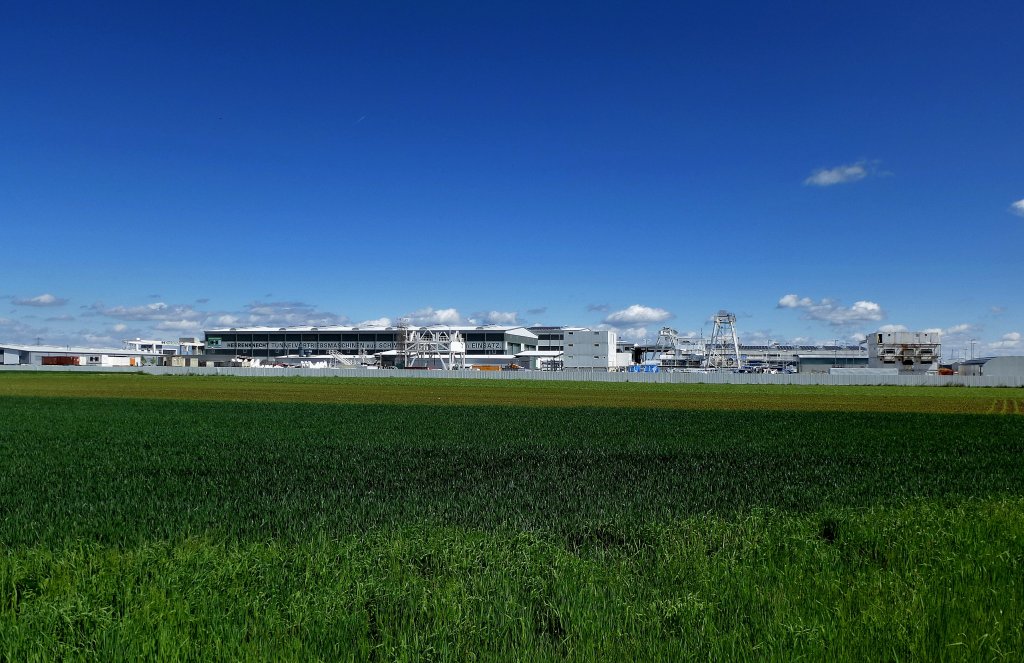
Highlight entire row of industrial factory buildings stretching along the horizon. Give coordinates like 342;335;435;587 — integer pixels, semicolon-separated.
0;310;991;374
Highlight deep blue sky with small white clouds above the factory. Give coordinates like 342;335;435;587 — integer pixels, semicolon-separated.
0;2;1024;355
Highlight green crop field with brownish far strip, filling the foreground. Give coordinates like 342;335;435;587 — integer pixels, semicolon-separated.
0;373;1024;661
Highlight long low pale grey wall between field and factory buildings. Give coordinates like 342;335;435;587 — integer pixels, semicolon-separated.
0;366;1024;387
